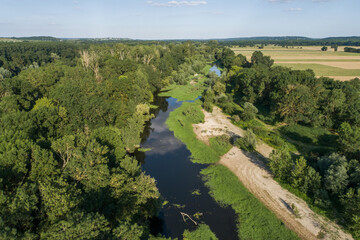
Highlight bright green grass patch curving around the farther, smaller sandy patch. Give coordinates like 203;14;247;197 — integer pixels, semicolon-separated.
166;102;231;163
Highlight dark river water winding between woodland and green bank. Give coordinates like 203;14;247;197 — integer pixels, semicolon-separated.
137;66;237;239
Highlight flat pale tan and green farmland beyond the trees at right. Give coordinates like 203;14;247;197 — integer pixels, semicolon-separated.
232;46;360;81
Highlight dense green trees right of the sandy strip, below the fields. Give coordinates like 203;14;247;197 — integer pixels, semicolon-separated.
203;48;360;238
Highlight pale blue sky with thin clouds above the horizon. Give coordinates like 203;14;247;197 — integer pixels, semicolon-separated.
0;0;360;39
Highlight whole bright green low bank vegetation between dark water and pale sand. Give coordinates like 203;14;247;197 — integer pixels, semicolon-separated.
166;101;298;239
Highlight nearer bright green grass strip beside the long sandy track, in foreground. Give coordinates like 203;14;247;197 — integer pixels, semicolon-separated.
201;165;298;239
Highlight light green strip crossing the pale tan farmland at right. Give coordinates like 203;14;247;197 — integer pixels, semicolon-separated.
275;63;360;76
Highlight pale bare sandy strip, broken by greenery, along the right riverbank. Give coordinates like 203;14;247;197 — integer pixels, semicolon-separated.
193;107;353;239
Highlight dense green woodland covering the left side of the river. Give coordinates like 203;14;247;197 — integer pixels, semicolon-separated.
0;42;219;239
